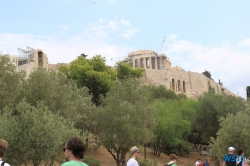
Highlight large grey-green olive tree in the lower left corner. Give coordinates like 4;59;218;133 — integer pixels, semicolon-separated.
0;100;79;166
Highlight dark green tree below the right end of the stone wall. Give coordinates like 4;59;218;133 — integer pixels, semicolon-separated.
193;91;244;143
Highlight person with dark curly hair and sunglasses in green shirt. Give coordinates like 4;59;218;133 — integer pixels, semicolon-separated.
61;137;88;166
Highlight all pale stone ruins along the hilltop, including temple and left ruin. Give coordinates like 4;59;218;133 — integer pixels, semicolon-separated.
3;47;235;98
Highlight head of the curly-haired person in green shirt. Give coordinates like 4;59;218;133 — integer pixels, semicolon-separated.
63;137;86;161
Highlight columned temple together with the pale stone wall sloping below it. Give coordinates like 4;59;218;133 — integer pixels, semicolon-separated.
124;50;235;98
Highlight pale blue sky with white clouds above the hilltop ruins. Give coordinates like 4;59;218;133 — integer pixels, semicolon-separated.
0;0;250;98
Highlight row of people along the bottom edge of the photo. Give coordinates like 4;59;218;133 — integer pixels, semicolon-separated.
0;137;250;166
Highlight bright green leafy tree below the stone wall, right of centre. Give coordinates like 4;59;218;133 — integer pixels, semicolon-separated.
151;99;197;156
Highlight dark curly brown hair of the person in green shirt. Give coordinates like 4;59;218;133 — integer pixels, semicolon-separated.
67;137;86;159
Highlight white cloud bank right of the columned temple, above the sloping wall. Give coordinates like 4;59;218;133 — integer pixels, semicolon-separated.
166;34;250;97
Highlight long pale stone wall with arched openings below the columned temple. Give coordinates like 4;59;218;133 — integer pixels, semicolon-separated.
145;69;235;98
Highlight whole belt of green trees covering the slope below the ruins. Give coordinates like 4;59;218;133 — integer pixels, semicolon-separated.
0;55;246;166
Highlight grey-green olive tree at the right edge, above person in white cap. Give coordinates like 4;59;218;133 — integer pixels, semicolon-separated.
210;102;250;158
